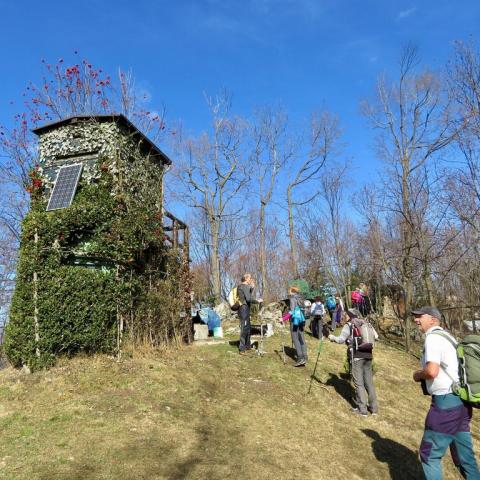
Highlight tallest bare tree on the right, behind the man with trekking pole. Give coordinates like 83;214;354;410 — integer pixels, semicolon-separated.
364;47;456;350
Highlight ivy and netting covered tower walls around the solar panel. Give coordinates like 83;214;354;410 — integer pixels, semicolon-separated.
5;118;190;368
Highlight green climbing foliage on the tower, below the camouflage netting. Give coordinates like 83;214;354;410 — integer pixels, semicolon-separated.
4;163;188;369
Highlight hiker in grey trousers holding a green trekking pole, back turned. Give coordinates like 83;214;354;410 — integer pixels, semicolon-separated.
328;308;378;417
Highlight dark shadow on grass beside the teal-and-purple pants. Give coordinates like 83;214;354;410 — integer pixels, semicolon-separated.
362;428;423;480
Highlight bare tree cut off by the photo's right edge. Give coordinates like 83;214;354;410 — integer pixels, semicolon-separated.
442;42;480;315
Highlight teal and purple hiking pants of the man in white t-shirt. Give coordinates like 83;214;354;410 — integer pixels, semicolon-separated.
420;393;480;480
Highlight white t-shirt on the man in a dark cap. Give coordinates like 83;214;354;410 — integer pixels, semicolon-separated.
421;326;458;395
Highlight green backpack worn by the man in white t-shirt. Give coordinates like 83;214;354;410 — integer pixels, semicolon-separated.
432;330;480;407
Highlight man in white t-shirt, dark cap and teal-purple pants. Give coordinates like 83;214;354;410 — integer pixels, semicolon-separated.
412;306;480;480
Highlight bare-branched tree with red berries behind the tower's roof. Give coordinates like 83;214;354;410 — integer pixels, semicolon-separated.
0;54;171;328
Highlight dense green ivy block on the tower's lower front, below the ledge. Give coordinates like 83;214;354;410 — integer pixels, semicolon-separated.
5;266;118;367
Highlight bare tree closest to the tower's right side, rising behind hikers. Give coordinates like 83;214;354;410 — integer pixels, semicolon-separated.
177;94;249;302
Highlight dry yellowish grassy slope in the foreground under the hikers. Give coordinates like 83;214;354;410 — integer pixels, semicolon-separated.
0;326;480;480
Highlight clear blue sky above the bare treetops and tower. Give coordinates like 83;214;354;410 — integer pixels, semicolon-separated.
0;0;480;188
